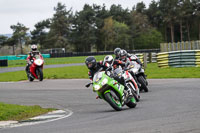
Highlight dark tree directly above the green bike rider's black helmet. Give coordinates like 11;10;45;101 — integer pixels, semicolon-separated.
73;4;97;52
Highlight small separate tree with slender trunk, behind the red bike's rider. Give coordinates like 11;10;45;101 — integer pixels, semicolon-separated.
10;23;29;54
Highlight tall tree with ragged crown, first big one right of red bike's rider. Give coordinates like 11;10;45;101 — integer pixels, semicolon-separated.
45;3;72;48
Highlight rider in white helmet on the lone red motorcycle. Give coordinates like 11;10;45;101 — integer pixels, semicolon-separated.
26;44;40;73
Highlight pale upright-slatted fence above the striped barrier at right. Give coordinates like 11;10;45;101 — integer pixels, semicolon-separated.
160;41;200;52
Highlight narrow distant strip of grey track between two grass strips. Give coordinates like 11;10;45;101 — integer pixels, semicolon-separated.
0;63;85;73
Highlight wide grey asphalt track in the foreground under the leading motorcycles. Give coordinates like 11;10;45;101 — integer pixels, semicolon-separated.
0;79;200;133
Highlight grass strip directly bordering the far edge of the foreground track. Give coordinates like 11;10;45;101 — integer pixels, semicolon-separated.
0;63;200;82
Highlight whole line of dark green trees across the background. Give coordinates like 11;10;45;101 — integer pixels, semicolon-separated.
0;0;200;53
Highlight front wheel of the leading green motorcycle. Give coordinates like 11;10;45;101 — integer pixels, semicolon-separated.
104;90;122;111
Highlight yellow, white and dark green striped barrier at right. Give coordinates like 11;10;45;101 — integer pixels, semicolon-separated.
157;50;200;67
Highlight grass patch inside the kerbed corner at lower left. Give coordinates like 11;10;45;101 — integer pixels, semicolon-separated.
0;102;55;121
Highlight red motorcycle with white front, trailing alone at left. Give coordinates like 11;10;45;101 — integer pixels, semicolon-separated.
27;54;44;81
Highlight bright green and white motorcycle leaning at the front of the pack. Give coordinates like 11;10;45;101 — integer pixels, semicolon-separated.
86;71;137;111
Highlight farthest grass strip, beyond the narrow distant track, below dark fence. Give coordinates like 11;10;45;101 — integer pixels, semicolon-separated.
8;55;105;67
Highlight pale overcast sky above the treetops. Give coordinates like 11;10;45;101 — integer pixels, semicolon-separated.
0;0;151;34
